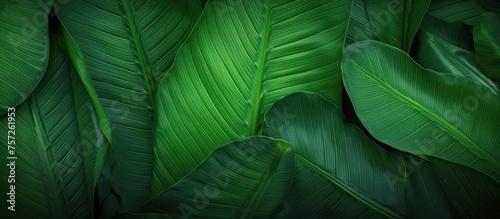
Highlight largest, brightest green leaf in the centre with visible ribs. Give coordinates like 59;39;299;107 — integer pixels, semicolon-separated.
151;0;352;194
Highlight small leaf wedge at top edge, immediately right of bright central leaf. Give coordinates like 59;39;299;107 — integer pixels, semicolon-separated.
346;0;377;44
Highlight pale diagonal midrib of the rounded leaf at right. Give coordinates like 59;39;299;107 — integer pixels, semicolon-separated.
351;61;500;180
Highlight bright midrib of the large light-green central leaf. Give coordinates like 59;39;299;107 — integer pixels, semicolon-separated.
246;0;273;137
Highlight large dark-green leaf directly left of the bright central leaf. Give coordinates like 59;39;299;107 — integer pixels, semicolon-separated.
57;0;201;211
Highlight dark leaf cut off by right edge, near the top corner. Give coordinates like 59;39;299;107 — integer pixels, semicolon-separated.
474;12;500;82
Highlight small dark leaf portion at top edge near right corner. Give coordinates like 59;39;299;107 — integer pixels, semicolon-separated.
427;0;486;25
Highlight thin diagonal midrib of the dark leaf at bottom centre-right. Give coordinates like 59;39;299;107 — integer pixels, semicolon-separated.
295;154;403;218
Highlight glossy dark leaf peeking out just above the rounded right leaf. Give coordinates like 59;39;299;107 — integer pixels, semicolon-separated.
416;32;498;93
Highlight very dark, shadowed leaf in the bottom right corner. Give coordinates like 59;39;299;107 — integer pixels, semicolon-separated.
431;158;500;218
